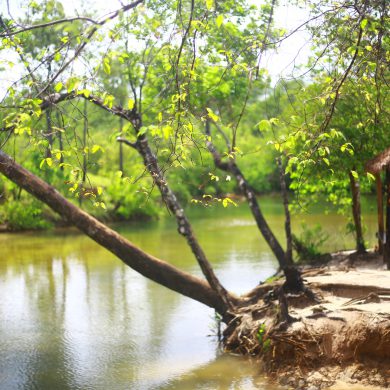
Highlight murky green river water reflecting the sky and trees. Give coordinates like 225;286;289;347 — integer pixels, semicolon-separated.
0;198;375;390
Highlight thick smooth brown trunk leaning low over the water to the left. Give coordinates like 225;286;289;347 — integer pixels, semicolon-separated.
0;151;233;318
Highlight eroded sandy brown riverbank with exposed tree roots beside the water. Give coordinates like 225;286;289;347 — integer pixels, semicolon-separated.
225;252;390;390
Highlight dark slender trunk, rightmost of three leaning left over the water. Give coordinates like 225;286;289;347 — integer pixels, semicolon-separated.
206;121;289;269
